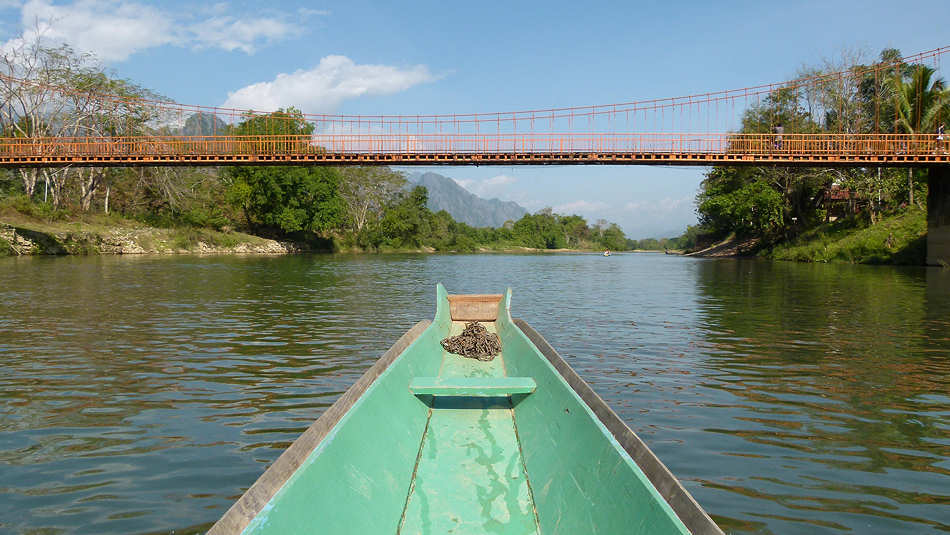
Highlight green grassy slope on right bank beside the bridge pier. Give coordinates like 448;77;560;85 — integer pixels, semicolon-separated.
763;207;927;265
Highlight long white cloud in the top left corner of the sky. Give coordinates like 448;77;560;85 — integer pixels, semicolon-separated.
0;0;308;62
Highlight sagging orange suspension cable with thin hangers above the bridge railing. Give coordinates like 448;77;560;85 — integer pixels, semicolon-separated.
0;46;950;135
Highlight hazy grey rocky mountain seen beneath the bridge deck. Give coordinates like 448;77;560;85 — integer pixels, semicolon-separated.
407;173;528;227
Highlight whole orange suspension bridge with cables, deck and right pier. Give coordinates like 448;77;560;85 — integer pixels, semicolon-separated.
0;46;950;263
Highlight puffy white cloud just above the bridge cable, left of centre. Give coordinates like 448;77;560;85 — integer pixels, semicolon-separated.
223;56;435;112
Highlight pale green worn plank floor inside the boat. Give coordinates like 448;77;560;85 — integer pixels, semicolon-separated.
400;322;539;535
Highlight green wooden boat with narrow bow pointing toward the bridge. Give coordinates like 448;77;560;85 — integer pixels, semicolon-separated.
208;284;722;535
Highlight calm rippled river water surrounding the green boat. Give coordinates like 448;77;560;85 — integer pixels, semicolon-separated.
0;255;950;534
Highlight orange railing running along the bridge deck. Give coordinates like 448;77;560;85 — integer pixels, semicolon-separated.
0;133;950;168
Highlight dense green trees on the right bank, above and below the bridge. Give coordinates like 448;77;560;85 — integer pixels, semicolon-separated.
681;49;950;253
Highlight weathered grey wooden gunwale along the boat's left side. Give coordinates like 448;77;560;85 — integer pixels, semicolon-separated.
207;319;432;535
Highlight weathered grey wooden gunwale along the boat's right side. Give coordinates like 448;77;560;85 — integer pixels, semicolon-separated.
511;318;724;535
